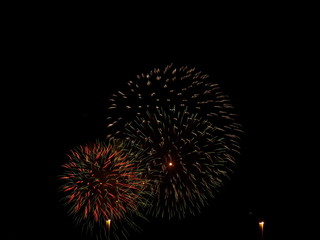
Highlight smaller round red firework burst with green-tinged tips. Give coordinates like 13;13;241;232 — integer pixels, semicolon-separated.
60;139;152;239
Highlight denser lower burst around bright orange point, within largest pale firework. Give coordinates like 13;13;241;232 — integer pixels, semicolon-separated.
124;109;238;218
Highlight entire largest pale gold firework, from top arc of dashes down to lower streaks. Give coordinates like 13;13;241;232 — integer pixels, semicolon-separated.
107;64;241;218
